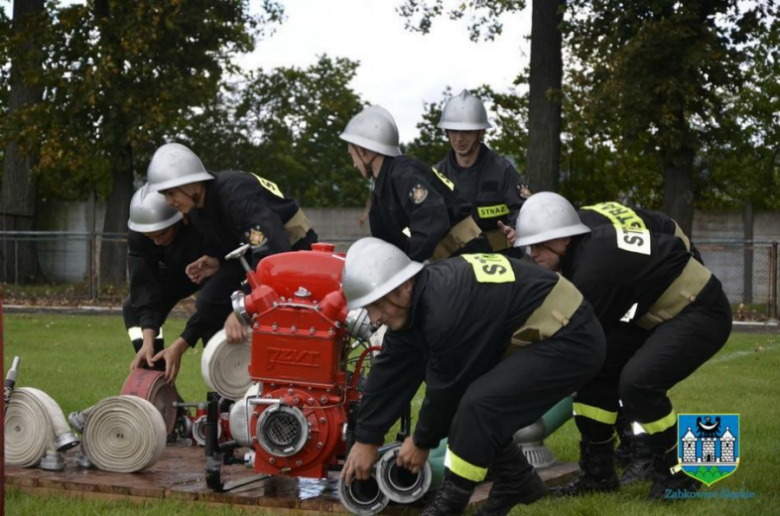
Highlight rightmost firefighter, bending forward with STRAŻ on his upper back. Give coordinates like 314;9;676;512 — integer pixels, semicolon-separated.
515;192;731;499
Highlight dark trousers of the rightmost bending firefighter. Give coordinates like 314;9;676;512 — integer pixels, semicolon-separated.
575;276;732;452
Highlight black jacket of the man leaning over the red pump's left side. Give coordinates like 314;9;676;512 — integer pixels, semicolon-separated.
189;171;308;268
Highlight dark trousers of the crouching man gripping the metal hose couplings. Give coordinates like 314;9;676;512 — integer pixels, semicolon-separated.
449;303;606;468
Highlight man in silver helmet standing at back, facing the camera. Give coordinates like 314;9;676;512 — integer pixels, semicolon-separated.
436;90;531;258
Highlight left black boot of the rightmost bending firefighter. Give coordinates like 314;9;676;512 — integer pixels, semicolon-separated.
550;437;620;496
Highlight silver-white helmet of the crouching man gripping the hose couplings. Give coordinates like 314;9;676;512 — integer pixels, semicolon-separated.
341;237;423;310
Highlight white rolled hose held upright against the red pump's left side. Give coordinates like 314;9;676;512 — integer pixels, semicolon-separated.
200;330;252;400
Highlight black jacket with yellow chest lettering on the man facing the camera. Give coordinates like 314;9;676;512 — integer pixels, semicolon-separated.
436;144;530;231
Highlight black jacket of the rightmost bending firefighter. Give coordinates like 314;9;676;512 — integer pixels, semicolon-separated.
561;224;692;331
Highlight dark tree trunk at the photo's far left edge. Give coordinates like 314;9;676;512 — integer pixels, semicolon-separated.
0;0;44;283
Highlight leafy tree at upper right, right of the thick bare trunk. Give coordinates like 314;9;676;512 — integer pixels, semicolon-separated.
565;0;777;231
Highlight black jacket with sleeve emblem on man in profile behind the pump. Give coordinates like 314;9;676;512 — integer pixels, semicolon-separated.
368;156;471;262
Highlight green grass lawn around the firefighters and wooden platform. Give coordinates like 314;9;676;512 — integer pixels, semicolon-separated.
4;314;780;516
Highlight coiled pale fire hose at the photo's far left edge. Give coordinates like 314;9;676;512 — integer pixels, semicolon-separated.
5;387;79;470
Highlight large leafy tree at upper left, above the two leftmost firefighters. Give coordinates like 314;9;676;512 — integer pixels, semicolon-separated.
7;0;282;281
